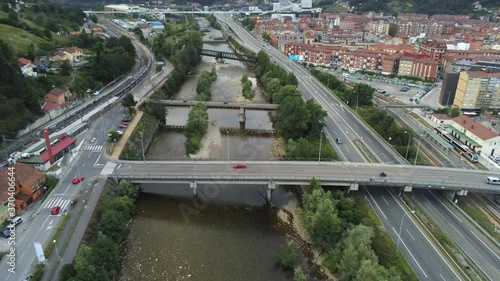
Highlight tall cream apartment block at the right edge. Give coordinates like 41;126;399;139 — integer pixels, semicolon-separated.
453;70;500;111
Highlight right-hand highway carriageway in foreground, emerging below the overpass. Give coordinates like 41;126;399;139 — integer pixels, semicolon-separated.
413;190;500;281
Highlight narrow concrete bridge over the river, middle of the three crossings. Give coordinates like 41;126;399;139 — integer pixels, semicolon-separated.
147;100;279;124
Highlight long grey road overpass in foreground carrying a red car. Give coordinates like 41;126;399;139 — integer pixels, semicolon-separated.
113;161;500;199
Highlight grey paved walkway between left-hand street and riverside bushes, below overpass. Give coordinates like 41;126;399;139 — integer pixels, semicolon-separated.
42;175;106;281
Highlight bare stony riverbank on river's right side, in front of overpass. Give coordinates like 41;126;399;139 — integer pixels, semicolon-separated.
278;197;337;281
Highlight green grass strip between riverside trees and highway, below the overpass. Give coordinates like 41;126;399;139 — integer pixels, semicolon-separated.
353;194;418;281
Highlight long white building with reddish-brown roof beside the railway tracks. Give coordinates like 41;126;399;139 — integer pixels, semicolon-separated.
448;115;500;156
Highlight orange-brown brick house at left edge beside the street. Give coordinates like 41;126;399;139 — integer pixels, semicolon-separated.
0;163;46;214
